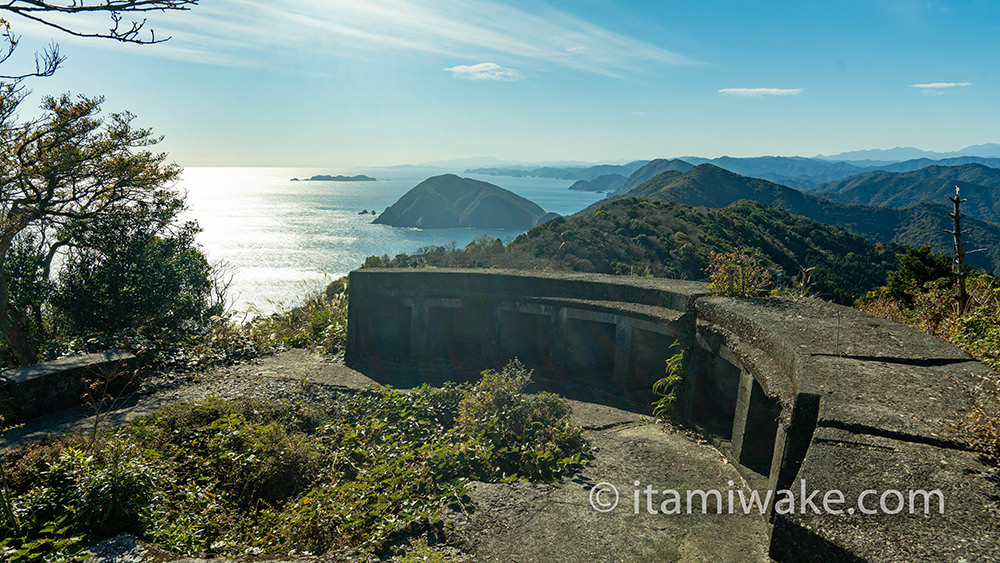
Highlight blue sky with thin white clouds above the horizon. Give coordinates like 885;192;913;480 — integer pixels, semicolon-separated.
0;0;1000;170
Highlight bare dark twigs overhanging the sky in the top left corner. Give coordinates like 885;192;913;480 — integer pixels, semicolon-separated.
0;0;198;81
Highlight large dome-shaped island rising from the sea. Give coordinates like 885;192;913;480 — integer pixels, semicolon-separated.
373;174;558;229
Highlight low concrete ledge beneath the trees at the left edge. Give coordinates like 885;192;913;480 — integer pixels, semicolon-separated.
0;352;135;425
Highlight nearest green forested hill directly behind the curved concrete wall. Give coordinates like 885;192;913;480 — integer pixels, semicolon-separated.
365;198;902;303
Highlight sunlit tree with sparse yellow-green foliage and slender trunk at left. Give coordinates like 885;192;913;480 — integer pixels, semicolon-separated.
0;90;183;364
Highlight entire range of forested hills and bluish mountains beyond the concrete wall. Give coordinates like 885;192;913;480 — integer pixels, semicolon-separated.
364;150;1000;303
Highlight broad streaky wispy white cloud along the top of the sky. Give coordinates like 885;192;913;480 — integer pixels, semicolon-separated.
9;0;700;76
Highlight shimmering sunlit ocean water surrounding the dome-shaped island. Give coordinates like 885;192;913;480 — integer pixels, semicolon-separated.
178;167;602;314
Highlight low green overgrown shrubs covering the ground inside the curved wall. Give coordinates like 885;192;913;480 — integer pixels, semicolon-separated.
0;363;588;561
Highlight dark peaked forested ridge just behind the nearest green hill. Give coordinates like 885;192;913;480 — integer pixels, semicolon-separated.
581;164;1000;272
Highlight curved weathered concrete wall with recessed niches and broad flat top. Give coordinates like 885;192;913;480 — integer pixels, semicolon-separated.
346;269;1000;562
